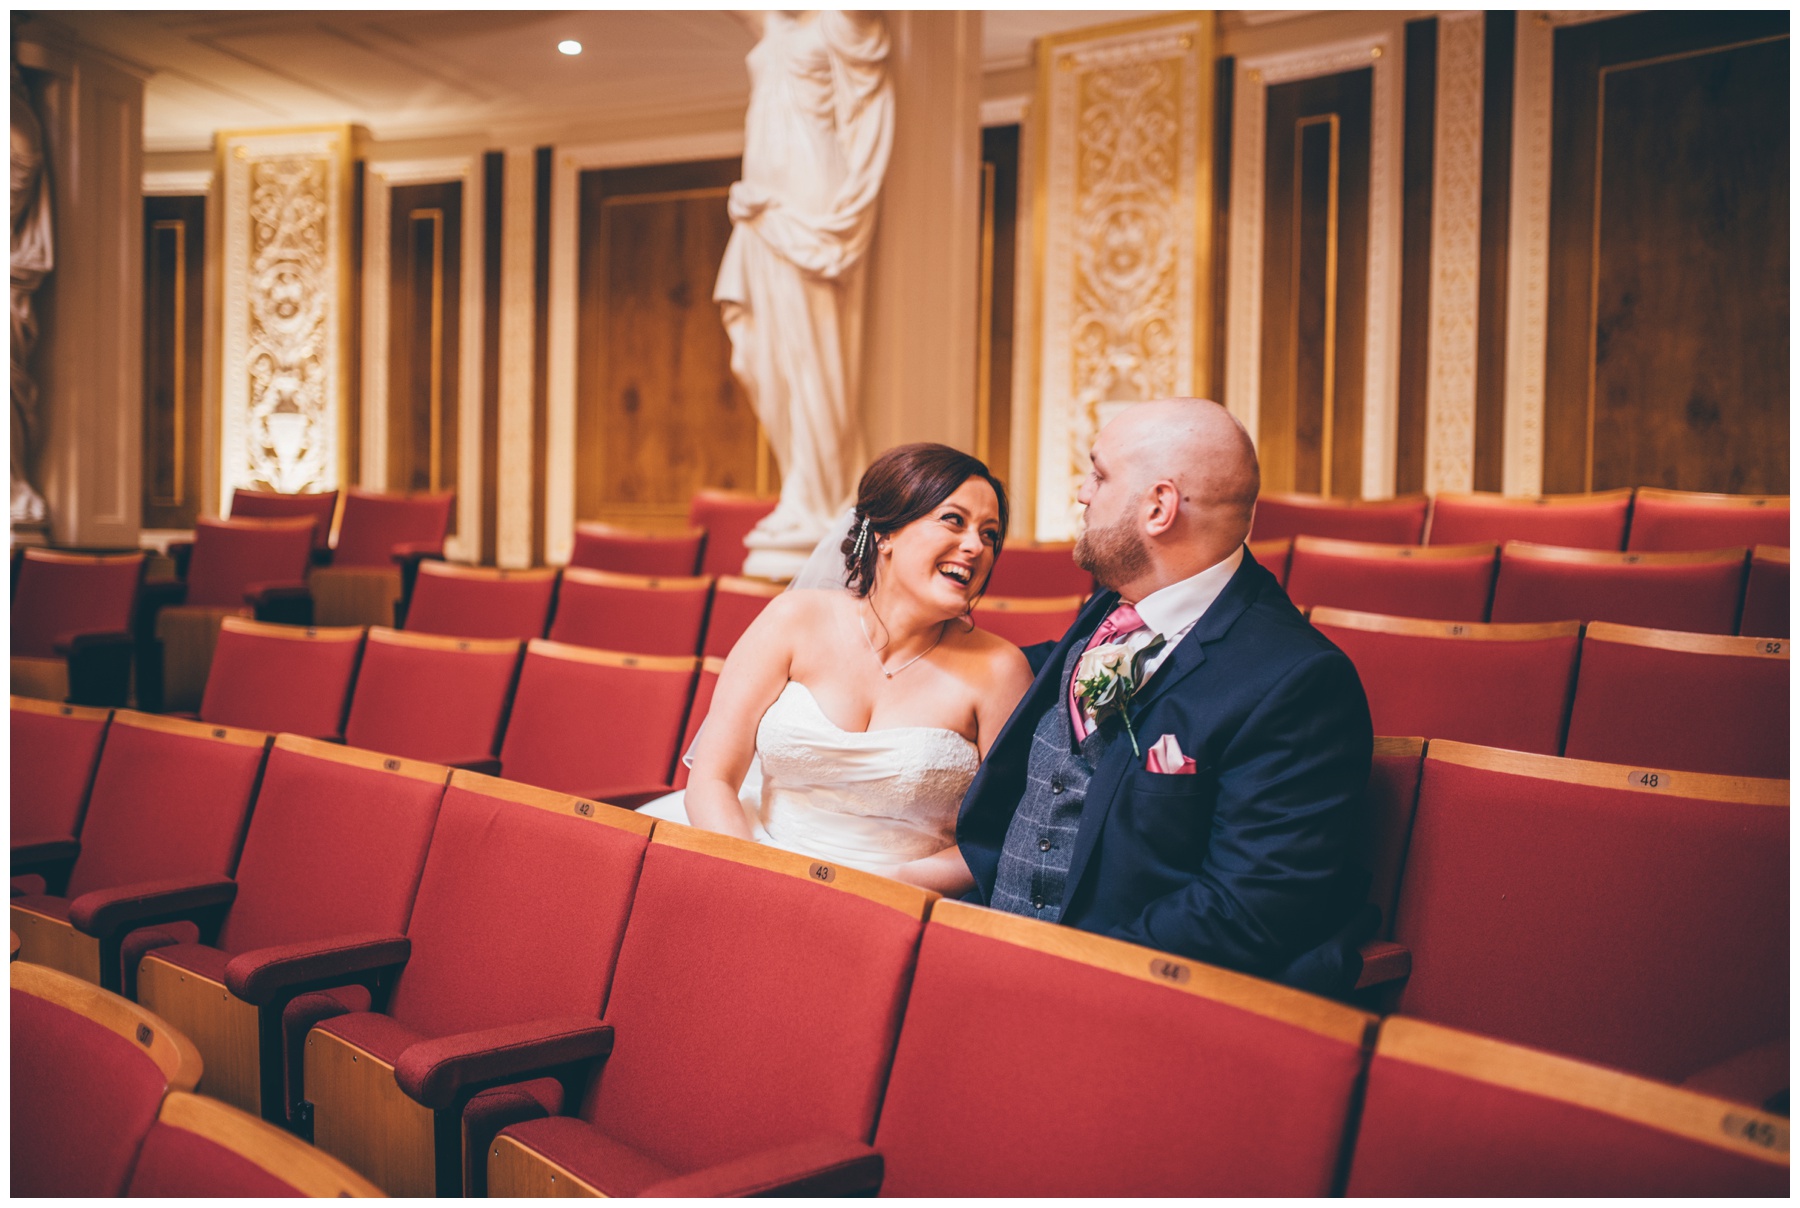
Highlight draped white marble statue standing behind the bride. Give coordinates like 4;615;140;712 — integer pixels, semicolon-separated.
713;13;895;578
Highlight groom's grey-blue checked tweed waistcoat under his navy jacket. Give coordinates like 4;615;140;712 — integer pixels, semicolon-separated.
992;643;1111;924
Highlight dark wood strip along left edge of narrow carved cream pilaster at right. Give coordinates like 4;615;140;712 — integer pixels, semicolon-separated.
1393;16;1438;495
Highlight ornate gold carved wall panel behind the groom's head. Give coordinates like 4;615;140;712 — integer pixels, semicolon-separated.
1035;13;1213;540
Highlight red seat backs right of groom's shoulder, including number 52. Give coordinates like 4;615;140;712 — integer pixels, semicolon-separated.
1310;609;1789;780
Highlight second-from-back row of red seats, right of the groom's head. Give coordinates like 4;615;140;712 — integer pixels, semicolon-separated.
1249;536;1787;637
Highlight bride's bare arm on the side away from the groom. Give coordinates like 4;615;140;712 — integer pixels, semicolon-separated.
686;592;810;839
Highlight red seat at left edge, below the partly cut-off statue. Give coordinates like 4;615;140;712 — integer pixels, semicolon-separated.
13;549;144;706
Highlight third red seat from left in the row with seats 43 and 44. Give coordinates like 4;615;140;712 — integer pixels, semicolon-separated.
132;735;450;1120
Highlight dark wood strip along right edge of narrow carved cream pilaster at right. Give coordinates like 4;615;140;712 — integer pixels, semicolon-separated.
1474;11;1517;491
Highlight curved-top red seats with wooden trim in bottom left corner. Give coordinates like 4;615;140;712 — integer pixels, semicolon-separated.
11;949;382;1199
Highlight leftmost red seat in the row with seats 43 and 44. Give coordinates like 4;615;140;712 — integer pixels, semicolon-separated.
11;697;112;893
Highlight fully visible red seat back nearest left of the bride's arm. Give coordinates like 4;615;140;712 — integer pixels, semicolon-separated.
500;641;700;807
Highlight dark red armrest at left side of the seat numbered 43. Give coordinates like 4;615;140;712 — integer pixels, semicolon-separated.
394;1015;612;1111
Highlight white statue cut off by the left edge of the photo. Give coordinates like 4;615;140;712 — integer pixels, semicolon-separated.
13;63;56;524
